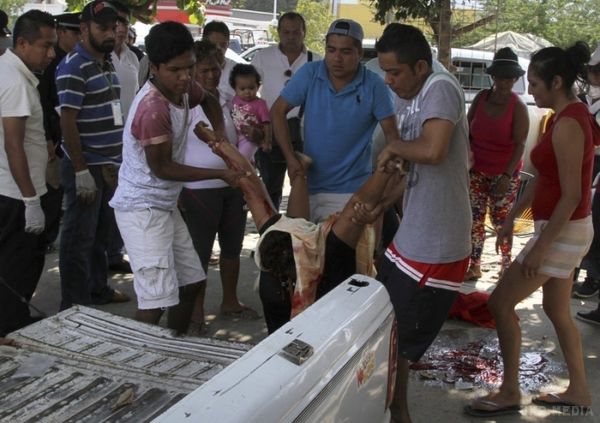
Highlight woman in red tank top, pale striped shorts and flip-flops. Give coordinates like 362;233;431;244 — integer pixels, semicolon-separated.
465;42;600;416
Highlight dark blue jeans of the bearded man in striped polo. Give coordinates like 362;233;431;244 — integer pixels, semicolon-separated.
58;161;114;310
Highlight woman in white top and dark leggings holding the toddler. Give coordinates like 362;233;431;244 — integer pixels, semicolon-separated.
180;40;264;330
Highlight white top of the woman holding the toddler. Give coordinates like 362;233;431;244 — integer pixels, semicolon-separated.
184;95;237;189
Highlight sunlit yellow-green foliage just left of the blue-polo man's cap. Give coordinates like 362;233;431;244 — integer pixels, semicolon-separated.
271;0;333;55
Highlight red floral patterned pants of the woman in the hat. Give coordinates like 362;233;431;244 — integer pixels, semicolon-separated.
470;171;521;268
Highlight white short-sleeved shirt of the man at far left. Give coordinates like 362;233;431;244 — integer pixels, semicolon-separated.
0;49;48;200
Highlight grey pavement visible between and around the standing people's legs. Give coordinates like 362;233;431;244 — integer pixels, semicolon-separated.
27;210;600;423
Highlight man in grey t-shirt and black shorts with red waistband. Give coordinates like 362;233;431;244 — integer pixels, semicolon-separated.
375;23;471;421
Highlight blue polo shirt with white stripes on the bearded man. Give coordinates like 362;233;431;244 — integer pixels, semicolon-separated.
56;43;123;165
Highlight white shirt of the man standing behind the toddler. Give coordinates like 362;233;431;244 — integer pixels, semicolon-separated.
252;45;321;118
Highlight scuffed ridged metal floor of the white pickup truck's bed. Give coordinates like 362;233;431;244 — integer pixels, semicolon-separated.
0;307;251;423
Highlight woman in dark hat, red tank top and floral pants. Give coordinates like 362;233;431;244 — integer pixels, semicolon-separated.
465;47;529;281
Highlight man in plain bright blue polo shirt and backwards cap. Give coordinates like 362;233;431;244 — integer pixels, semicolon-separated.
271;19;398;222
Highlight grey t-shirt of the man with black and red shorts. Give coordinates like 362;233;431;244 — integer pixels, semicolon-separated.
394;72;471;263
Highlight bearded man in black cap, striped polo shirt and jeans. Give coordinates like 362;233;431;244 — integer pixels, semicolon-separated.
56;0;129;309
